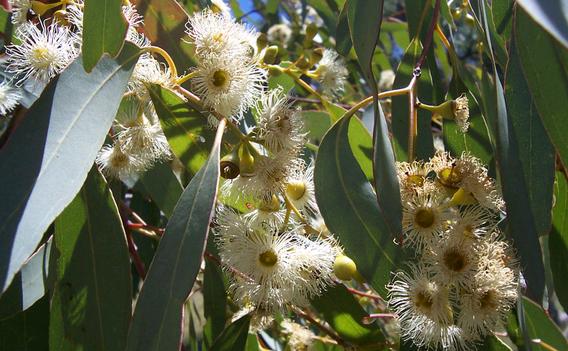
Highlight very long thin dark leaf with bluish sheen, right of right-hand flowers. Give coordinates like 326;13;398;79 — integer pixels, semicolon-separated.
481;5;545;301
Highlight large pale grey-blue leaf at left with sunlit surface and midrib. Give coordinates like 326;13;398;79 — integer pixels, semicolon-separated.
0;44;139;291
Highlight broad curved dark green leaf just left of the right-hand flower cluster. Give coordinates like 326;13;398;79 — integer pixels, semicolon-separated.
315;118;402;295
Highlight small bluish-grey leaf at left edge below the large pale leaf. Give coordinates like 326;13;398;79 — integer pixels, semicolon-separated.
0;238;51;319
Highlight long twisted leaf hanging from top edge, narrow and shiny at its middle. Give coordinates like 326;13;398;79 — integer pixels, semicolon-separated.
347;0;402;235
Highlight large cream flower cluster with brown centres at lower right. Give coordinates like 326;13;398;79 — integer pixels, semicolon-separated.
388;152;519;350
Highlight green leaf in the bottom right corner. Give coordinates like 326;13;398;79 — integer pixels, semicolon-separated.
523;297;568;351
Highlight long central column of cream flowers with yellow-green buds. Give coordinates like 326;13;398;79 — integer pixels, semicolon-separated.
180;10;340;327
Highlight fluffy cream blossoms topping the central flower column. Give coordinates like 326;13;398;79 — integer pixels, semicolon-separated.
186;10;266;121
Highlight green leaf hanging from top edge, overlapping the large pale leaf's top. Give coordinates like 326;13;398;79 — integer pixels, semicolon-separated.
81;0;128;72
